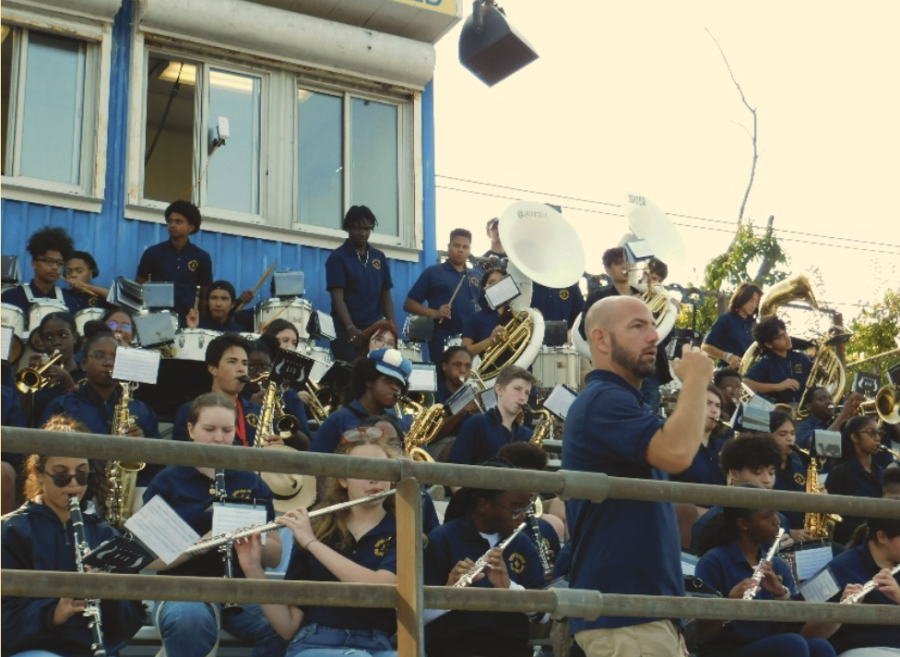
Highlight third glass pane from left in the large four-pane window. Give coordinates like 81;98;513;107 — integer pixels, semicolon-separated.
297;89;344;229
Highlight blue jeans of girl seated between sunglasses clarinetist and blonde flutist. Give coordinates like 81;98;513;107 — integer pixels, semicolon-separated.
152;600;286;657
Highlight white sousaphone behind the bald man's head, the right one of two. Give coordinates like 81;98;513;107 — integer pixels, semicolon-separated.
572;193;687;361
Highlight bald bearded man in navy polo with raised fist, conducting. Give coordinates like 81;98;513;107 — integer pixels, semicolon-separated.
562;296;713;657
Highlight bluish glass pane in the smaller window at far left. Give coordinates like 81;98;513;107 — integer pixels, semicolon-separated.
19;32;86;185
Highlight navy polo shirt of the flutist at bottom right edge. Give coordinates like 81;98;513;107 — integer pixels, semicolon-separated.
828;543;900;654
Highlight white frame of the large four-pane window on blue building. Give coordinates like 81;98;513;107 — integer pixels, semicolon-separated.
125;29;424;262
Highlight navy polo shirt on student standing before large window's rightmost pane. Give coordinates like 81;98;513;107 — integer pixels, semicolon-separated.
325;240;394;332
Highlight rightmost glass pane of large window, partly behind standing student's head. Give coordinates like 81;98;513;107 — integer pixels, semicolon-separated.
349;98;400;235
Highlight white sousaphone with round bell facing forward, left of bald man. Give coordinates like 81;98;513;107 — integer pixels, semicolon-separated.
473;201;584;386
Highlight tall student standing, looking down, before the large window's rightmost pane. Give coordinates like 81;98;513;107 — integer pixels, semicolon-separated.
325;205;394;363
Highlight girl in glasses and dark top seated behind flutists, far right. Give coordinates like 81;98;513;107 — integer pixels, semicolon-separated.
825;415;884;543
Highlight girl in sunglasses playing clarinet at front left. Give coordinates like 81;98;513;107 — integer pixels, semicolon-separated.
0;416;144;657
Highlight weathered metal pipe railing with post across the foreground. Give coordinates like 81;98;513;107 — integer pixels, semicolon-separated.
0;427;900;657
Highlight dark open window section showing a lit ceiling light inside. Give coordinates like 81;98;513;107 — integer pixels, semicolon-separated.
144;55;197;203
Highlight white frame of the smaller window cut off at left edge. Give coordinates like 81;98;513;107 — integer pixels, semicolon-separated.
0;7;112;212
